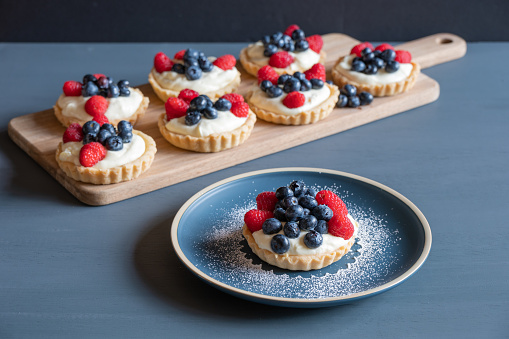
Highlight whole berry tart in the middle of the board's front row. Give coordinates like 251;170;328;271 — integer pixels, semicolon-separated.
158;89;256;152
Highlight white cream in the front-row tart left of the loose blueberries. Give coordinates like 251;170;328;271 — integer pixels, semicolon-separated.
249;85;330;115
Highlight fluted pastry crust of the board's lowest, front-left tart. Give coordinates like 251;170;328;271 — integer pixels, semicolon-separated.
56;130;157;185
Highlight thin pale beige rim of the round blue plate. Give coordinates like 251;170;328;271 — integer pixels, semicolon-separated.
170;167;432;306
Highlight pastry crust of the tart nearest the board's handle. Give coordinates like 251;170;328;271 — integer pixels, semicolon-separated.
332;57;421;97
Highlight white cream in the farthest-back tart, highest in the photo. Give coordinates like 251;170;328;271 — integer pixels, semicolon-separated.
246;41;320;72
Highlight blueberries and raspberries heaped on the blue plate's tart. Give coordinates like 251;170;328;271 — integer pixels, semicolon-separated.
244;180;354;254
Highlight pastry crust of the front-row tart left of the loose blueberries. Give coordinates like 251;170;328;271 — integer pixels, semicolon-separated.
246;83;339;125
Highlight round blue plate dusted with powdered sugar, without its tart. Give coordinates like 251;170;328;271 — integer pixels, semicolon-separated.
171;167;431;307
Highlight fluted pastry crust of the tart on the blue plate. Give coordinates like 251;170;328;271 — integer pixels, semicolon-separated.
242;224;355;271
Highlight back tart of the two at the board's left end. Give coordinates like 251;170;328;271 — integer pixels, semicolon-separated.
53;74;149;126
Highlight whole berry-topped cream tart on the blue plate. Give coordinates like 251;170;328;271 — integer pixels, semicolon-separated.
242;181;359;271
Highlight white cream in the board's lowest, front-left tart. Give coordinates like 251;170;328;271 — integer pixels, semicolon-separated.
58;134;145;169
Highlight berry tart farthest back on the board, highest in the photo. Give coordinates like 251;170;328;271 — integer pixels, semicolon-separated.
240;25;325;76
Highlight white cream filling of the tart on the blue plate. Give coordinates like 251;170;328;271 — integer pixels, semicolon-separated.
253;214;359;255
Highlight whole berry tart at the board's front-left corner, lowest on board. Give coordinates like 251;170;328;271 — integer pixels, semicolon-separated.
56;120;157;184
